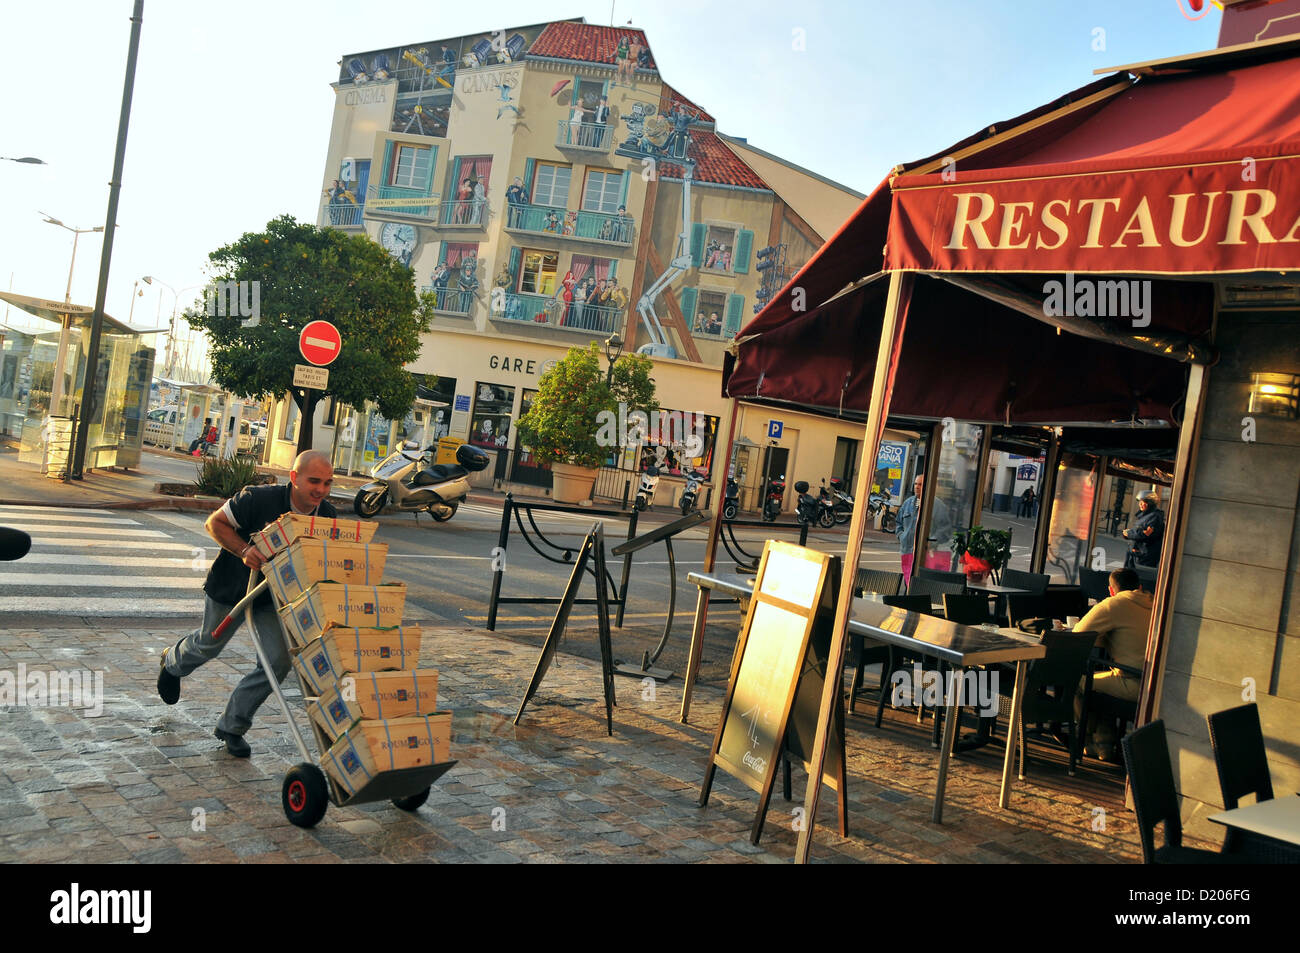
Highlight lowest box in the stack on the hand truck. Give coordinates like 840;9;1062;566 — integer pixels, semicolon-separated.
321;711;451;794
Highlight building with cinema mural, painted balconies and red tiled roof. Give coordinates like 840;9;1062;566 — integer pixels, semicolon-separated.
272;21;863;503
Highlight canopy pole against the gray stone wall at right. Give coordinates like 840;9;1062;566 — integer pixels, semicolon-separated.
1138;364;1209;727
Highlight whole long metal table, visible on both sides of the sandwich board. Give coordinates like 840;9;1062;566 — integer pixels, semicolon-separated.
680;572;1047;824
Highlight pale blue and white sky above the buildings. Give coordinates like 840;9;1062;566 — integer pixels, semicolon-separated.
0;0;1221;361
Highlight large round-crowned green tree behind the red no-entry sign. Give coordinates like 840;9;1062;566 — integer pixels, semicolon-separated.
185;216;433;452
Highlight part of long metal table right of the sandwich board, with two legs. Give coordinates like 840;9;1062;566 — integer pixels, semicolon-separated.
849;598;1047;824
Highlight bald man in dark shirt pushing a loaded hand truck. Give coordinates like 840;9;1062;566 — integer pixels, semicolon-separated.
159;450;338;758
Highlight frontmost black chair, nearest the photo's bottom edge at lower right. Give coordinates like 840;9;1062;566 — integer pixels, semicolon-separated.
1119;720;1238;863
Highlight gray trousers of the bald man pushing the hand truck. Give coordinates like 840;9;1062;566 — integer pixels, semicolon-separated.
164;595;290;735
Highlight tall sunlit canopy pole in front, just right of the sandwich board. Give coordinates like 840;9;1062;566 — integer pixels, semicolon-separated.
794;272;914;863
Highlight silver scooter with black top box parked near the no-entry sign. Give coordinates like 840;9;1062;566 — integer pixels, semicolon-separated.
352;441;489;523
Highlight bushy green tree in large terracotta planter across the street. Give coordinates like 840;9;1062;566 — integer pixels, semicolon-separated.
519;341;659;503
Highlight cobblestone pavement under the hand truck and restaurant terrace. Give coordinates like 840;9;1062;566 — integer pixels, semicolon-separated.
0;627;1222;863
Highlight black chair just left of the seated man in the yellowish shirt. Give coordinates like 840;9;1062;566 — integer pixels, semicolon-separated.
997;629;1097;780
